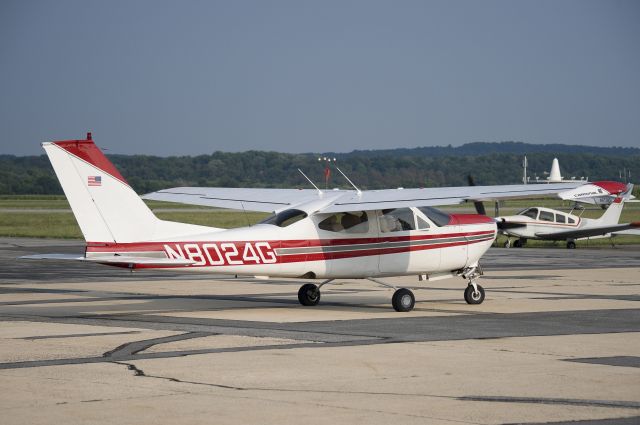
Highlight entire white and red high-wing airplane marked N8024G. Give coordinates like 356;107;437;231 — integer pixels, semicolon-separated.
22;133;616;311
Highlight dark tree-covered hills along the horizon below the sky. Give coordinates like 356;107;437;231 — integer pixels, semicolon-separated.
0;142;640;195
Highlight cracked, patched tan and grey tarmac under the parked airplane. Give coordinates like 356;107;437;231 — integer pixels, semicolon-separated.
0;238;640;424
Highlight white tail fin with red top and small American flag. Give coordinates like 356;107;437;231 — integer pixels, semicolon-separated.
42;133;218;243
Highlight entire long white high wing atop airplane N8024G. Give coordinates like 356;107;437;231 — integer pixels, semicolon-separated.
142;182;582;212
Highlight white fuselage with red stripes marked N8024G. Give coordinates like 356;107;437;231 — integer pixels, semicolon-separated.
86;209;496;278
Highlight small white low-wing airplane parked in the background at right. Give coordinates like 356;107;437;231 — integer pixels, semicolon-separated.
496;182;640;249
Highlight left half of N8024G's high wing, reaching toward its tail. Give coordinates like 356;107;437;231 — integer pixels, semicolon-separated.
142;187;340;212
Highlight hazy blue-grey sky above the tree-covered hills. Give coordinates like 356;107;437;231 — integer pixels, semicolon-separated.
0;0;640;155
